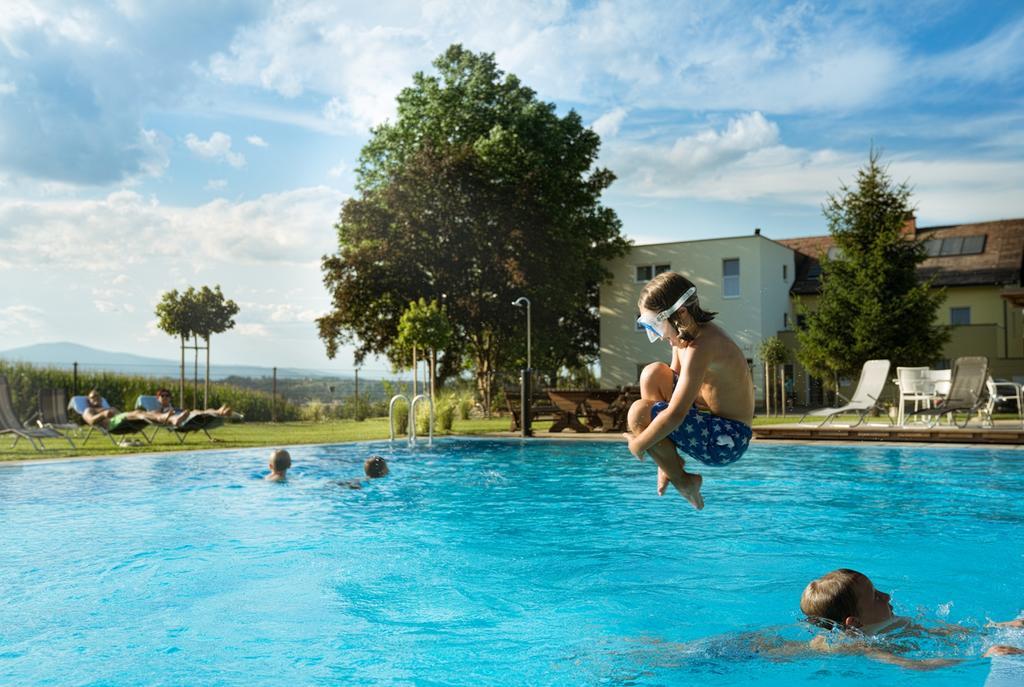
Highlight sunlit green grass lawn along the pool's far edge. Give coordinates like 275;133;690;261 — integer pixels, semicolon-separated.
0;415;1017;463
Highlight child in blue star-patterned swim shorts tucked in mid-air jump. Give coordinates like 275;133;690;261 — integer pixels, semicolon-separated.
625;272;754;509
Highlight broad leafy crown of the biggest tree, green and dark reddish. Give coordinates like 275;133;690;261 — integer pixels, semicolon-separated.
317;45;628;397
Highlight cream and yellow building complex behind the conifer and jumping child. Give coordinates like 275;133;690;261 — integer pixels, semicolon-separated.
600;219;1024;405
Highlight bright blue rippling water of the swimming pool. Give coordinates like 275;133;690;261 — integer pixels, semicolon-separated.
0;440;1024;686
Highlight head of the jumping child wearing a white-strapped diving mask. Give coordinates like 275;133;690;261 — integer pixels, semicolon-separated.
637;272;718;342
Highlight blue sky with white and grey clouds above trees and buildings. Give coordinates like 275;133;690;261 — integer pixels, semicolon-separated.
0;0;1024;374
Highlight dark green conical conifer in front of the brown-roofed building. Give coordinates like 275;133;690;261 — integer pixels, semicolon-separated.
797;149;949;387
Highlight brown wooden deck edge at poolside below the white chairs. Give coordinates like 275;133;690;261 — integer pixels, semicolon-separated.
754;422;1024;444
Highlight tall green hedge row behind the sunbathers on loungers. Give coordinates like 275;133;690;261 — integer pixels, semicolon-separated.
0;360;300;422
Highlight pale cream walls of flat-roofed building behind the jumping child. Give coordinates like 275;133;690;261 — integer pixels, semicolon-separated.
600;235;794;395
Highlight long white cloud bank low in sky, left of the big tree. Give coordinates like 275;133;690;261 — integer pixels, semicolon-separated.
0;186;344;272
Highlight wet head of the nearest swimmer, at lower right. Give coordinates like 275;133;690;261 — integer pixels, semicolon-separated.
800;568;893;628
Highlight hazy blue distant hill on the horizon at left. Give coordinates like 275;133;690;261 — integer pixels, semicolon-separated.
0;342;361;380
